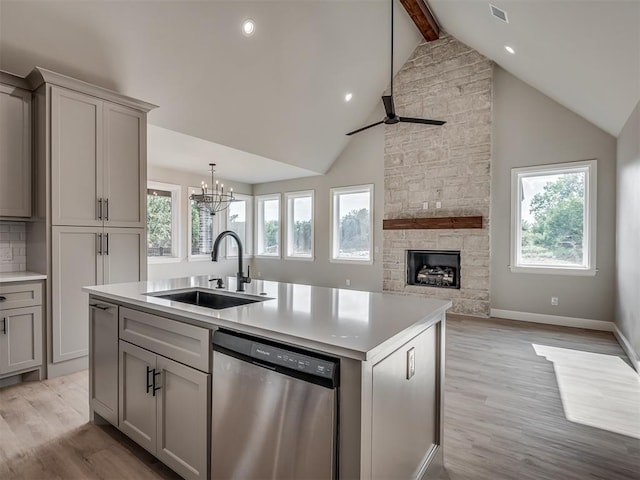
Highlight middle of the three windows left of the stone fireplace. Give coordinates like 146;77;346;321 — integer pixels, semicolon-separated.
285;191;313;260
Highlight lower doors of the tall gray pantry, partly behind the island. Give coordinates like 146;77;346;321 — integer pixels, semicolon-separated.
51;227;146;363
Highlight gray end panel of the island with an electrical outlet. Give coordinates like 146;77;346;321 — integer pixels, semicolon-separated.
371;325;439;480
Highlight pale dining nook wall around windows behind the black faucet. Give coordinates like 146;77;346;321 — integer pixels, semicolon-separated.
147;165;251;280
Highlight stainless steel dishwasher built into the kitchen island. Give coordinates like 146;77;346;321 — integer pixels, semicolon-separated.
211;330;340;480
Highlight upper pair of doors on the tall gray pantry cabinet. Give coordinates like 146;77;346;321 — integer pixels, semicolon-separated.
51;86;146;227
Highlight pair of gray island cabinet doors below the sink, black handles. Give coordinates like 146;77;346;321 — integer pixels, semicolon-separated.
118;340;211;479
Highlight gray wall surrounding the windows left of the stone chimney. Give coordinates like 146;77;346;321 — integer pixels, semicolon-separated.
251;116;384;291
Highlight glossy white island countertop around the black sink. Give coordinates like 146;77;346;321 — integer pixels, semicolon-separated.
83;276;451;360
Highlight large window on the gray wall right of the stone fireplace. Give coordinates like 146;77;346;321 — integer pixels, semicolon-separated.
511;160;596;275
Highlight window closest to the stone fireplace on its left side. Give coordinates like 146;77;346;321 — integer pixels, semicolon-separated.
331;185;373;264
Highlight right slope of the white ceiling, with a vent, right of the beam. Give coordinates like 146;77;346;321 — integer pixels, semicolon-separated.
429;0;640;136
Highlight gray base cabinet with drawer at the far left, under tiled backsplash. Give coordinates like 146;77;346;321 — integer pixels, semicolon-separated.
0;282;43;376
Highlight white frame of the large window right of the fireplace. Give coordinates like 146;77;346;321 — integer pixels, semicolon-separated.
509;159;598;276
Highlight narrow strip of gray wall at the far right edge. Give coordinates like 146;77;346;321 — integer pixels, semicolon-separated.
615;102;640;364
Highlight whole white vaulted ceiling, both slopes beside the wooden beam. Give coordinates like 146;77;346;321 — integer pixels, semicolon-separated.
0;0;640;182
